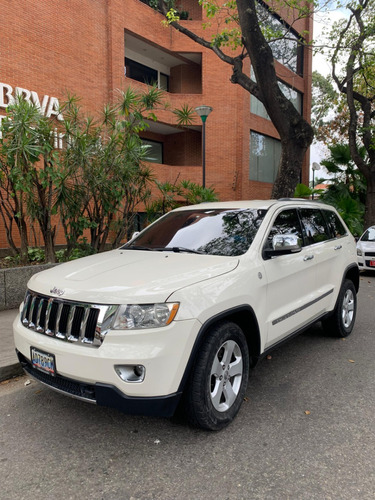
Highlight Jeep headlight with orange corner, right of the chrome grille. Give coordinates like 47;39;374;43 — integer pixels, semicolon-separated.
112;303;179;330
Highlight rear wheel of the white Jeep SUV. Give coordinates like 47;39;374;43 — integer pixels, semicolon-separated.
322;280;357;338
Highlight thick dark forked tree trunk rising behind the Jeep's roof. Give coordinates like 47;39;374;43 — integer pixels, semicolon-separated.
166;0;314;198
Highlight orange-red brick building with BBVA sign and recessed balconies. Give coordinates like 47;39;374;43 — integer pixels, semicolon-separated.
0;0;312;248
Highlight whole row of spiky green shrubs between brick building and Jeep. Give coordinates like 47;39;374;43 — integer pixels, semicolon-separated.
0;87;219;263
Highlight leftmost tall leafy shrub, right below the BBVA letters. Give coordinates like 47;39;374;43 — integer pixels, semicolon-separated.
0;96;59;263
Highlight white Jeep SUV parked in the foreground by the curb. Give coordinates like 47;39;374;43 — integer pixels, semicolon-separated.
14;199;359;430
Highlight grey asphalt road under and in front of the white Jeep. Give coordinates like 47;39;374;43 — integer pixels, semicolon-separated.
0;275;375;500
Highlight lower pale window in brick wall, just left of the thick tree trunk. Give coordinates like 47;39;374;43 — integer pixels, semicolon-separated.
249;132;281;182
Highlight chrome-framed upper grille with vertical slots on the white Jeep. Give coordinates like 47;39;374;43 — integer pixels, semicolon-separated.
21;290;118;347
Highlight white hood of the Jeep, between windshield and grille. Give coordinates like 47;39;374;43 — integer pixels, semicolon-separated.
28;250;238;304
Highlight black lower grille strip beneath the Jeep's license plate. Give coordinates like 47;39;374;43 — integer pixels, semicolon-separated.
17;352;96;403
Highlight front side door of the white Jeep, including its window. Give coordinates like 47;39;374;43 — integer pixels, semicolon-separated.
263;208;317;348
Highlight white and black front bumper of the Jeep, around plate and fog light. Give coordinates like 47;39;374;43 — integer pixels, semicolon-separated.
13;317;201;416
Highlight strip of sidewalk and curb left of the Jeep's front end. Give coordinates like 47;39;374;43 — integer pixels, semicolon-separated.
0;309;24;382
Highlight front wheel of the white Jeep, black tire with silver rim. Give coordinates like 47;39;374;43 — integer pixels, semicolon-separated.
183;322;250;431
